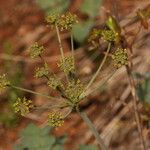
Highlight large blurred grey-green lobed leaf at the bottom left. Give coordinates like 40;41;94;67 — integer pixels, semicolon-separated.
14;124;56;150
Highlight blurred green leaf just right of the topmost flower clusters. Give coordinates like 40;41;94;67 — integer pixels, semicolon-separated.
72;20;94;43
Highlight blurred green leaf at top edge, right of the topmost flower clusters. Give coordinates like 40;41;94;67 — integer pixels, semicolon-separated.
80;0;102;18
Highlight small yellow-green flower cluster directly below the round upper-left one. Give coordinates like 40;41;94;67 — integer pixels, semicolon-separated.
35;63;49;78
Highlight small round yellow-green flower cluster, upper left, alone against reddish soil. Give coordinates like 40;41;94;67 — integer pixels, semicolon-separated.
29;42;44;58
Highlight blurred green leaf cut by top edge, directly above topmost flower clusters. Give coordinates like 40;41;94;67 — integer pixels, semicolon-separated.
36;0;70;13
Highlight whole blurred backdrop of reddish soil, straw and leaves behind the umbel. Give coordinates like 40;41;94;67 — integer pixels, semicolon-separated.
0;0;150;150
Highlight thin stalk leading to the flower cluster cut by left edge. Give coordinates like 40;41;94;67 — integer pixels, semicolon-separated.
10;85;58;100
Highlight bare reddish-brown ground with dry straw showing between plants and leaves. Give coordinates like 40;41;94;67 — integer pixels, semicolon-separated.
0;0;150;150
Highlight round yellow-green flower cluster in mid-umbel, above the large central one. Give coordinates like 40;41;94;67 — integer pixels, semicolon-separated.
58;56;75;74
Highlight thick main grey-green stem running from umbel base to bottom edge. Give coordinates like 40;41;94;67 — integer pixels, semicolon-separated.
77;108;108;150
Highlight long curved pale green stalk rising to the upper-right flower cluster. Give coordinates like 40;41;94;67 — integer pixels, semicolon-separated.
86;43;111;90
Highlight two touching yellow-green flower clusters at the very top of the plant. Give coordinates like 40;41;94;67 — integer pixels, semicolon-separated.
46;12;78;31
